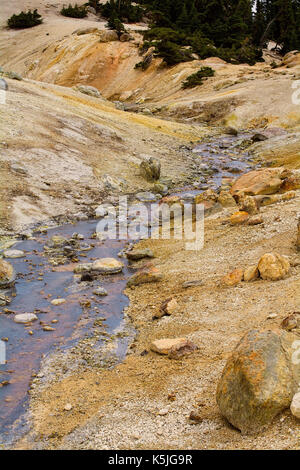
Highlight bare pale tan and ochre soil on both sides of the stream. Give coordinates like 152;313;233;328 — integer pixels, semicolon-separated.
0;1;300;449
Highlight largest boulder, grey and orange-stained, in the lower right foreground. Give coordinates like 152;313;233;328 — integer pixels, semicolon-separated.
216;330;297;434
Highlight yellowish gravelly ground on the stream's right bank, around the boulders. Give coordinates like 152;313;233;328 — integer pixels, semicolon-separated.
17;186;300;449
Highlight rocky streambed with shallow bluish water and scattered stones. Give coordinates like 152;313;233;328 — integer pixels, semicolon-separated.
0;133;264;444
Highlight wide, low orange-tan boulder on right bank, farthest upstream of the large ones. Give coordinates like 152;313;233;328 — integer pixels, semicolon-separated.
230;168;290;197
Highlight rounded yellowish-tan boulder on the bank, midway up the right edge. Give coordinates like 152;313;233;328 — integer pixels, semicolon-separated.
258;253;291;281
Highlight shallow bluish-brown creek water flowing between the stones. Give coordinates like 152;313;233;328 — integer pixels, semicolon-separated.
0;134;258;444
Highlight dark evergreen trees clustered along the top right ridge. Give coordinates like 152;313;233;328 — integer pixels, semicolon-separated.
135;0;300;65
